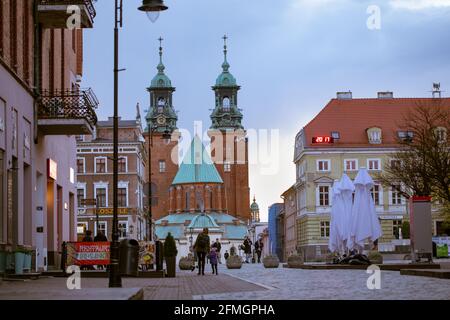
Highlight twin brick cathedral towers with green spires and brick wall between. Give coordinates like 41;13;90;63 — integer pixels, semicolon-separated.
144;37;251;222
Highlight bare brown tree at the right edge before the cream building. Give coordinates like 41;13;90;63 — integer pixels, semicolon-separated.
377;99;450;217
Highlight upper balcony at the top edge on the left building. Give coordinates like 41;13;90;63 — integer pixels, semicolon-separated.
38;0;96;29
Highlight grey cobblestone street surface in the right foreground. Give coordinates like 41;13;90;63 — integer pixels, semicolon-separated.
195;264;450;300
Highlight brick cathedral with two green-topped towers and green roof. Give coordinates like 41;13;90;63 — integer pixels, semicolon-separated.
145;36;252;259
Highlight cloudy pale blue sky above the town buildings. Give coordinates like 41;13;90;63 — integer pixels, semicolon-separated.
83;0;450;221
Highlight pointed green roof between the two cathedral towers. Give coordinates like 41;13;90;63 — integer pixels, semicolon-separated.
172;135;223;184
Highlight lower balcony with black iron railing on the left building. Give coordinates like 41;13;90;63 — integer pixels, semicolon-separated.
38;89;98;135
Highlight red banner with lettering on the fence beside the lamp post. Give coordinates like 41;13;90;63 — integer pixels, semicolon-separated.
67;242;110;266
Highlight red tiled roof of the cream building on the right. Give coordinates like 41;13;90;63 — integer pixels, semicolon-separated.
304;98;450;148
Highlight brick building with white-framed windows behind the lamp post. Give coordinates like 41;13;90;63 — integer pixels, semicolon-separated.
77;114;148;240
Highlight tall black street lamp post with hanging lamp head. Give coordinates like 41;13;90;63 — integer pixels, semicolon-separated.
109;0;168;288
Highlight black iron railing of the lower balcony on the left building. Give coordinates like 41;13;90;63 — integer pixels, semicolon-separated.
38;88;99;128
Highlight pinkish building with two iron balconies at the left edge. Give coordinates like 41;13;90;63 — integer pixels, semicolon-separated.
0;0;98;270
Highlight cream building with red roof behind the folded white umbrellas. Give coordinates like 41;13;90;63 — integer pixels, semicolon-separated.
294;92;450;259
